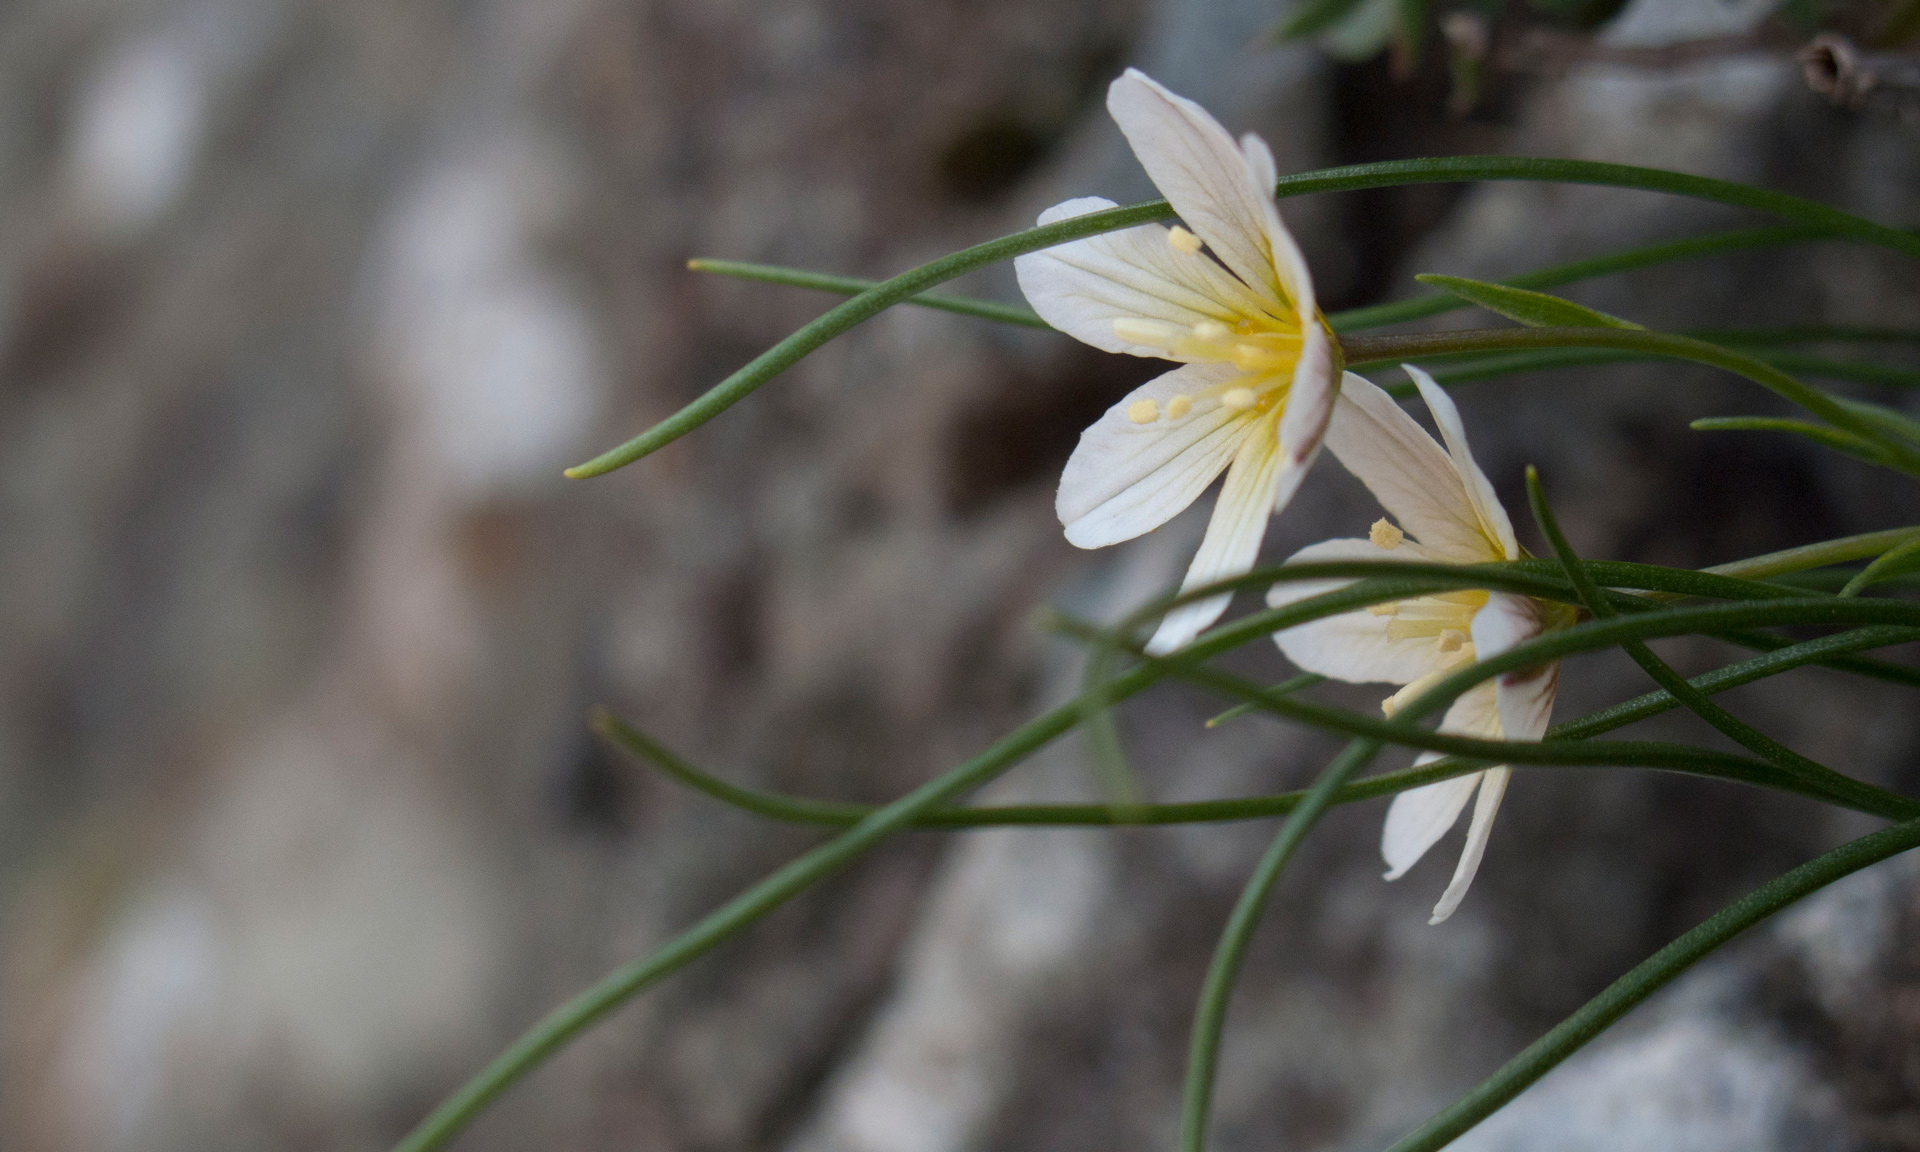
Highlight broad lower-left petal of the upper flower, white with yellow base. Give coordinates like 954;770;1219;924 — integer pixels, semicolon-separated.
1054;365;1254;547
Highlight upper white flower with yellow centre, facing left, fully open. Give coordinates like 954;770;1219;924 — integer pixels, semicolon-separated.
1014;69;1338;655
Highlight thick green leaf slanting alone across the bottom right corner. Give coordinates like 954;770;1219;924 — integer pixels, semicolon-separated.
1388;820;1920;1152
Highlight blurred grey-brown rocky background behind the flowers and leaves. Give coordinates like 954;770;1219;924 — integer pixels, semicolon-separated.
0;0;1920;1152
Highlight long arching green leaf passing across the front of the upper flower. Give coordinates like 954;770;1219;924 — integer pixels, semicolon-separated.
566;156;1920;480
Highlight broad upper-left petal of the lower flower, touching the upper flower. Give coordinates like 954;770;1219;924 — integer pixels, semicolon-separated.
1327;372;1511;564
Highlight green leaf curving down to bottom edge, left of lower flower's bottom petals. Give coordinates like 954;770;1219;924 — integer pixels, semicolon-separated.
1181;739;1380;1152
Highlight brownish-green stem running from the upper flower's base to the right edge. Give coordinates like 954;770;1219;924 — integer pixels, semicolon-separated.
1342;328;1920;474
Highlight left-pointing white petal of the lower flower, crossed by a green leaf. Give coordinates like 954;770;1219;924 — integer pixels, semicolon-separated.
1267;540;1444;684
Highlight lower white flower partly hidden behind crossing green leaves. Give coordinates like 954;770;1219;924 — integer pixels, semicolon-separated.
1267;365;1572;924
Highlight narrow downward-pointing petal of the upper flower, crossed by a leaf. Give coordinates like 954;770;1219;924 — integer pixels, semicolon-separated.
1146;417;1300;657
